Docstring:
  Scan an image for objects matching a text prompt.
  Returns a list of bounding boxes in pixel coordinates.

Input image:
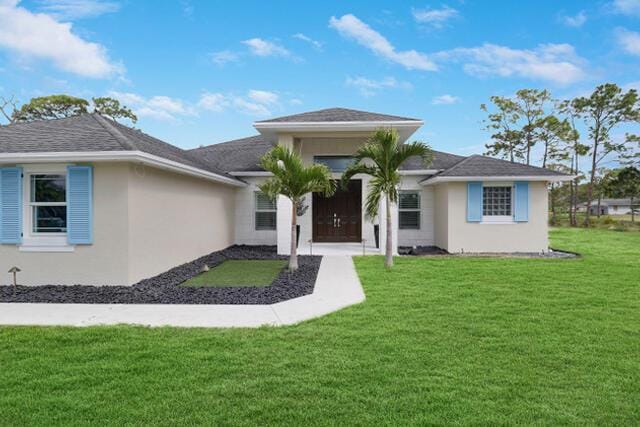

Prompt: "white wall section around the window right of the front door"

[398,176,435,246]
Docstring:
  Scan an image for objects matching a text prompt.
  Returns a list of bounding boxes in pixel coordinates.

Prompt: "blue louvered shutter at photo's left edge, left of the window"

[0,168,22,245]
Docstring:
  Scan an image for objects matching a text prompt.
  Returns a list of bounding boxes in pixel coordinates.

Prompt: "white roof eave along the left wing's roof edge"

[0,151,247,187]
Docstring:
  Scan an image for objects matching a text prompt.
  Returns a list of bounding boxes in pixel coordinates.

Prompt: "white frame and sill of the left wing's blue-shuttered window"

[19,164,74,252]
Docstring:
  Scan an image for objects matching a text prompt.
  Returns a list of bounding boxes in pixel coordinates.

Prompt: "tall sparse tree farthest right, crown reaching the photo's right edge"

[572,83,640,226]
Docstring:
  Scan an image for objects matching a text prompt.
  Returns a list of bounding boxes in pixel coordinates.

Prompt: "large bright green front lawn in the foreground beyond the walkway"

[0,229,640,425]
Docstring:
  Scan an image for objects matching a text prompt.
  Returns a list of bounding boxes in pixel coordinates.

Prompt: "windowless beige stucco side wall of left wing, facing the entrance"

[128,165,236,283]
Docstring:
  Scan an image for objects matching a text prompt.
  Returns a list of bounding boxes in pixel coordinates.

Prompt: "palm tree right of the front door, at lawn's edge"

[342,128,432,268]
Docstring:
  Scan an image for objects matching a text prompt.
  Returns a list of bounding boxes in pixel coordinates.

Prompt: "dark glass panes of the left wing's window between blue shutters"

[29,174,67,234]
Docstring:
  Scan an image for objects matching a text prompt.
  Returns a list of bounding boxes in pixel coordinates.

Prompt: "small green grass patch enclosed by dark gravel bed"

[180,259,287,287]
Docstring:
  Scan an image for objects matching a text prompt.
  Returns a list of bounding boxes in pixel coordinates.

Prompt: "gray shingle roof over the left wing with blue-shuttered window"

[0,114,234,179]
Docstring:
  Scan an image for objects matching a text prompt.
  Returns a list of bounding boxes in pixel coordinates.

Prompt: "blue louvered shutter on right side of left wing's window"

[67,166,93,245]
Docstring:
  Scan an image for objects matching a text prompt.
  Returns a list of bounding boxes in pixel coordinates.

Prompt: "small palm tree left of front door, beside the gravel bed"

[259,145,335,271]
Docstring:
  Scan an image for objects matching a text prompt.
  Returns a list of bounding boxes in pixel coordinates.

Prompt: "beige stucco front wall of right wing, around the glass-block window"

[436,182,549,253]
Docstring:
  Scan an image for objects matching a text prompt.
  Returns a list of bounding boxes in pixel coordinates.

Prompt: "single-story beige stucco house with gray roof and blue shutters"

[0,108,571,285]
